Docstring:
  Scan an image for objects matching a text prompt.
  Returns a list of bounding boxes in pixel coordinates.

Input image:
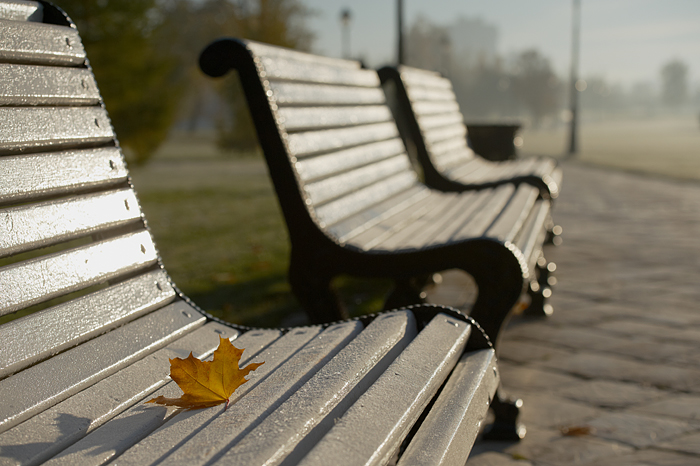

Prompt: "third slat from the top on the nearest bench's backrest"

[0,64,101,106]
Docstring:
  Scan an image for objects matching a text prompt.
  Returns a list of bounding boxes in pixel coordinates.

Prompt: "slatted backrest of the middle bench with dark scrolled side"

[200,39,422,245]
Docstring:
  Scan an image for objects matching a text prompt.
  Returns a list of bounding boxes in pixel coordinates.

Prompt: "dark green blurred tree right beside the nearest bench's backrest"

[61,0,184,163]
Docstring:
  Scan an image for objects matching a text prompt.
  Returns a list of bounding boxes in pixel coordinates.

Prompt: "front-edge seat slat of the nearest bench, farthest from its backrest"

[398,349,499,466]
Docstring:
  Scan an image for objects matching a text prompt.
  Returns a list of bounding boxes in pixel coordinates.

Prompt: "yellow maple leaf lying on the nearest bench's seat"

[146,337,264,409]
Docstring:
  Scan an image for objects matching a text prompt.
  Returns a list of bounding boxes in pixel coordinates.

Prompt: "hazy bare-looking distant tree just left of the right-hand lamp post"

[513,49,561,127]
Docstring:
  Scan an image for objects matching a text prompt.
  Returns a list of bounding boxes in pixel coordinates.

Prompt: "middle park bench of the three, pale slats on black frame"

[200,39,553,336]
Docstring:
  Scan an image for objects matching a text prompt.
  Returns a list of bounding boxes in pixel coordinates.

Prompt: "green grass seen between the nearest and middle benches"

[134,160,390,327]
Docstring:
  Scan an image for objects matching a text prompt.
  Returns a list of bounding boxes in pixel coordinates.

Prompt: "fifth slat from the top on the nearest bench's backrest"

[0,147,128,203]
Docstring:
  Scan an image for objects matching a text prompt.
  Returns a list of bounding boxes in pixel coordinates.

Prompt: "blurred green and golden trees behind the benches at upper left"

[61,0,312,163]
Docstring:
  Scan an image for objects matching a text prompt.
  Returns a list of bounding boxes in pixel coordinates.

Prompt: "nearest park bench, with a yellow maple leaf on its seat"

[0,1,516,465]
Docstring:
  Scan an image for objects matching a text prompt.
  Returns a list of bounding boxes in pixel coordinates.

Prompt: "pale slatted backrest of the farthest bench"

[379,66,476,179]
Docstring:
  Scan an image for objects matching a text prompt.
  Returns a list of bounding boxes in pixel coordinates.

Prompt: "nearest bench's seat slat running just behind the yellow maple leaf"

[0,322,239,464]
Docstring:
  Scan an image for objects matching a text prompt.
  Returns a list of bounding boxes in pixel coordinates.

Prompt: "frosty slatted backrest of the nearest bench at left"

[0,1,177,378]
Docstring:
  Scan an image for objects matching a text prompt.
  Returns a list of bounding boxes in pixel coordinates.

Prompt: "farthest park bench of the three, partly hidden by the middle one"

[378,66,562,199]
